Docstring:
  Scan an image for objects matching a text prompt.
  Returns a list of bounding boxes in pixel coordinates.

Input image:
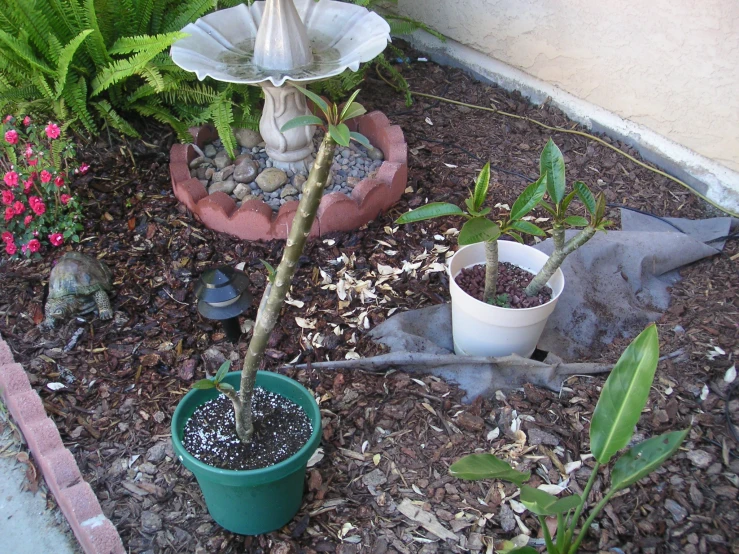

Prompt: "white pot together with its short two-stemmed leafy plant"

[397,139,610,357]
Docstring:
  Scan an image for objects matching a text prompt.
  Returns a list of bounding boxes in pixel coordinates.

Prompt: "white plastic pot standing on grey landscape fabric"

[449,241,565,358]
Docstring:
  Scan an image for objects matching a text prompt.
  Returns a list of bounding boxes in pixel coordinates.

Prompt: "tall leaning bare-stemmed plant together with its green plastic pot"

[172,87,369,535]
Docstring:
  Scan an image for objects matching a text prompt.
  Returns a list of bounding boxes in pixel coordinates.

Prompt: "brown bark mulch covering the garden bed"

[0,48,739,554]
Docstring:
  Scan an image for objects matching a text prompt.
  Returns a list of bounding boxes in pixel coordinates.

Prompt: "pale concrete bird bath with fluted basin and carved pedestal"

[171,0,390,173]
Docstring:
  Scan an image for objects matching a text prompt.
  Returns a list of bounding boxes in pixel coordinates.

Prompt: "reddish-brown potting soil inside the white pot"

[454,262,552,308]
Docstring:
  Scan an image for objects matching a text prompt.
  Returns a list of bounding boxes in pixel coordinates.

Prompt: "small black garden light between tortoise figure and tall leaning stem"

[195,266,252,343]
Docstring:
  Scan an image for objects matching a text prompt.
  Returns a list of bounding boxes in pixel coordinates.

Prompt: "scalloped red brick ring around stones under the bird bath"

[169,111,408,240]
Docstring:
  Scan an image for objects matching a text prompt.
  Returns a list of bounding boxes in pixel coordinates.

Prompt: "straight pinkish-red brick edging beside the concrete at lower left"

[0,338,126,554]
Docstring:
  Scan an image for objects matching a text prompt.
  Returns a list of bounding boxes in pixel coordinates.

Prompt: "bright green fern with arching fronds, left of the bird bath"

[0,0,258,153]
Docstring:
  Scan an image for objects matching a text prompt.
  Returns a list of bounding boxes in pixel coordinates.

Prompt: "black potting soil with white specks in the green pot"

[182,387,313,469]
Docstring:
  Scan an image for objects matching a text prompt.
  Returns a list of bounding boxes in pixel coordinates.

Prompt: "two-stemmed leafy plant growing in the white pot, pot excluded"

[396,139,610,304]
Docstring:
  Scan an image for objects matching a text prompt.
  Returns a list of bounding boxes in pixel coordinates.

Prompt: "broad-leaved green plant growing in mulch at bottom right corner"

[449,325,689,554]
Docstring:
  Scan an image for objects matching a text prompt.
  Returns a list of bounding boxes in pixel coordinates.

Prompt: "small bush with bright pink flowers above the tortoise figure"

[0,115,89,257]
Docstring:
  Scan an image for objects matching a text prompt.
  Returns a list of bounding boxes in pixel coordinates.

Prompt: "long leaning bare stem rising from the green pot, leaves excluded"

[236,133,336,443]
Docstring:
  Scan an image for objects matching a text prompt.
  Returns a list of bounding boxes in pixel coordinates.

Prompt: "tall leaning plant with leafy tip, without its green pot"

[195,91,369,443]
